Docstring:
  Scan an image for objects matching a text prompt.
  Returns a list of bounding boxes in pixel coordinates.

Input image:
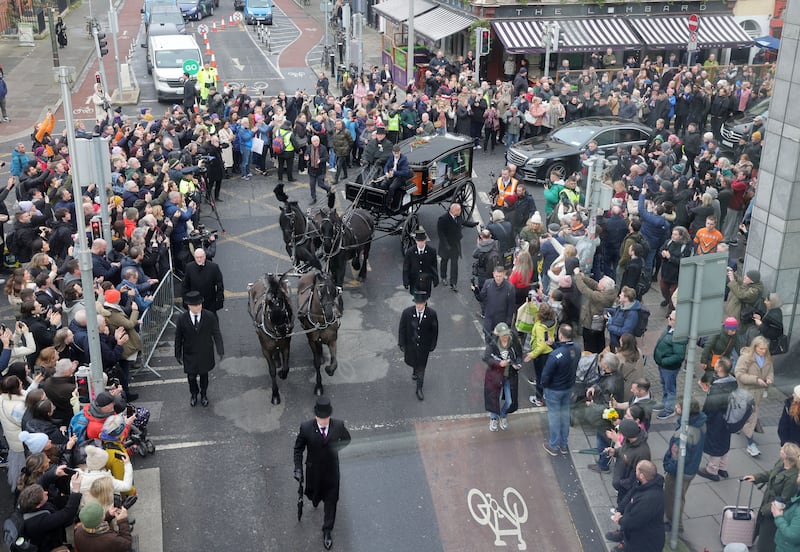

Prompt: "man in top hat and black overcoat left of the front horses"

[175,291,225,406]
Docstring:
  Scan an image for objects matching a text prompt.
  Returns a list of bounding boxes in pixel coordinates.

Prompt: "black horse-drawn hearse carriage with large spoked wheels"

[345,134,475,253]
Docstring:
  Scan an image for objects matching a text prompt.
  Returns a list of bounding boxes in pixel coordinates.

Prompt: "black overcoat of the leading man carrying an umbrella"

[294,418,350,506]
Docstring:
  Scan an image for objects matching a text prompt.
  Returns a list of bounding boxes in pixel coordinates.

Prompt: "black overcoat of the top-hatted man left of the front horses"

[175,309,225,374]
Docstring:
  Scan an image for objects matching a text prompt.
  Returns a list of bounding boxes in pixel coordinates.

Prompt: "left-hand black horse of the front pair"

[248,274,294,404]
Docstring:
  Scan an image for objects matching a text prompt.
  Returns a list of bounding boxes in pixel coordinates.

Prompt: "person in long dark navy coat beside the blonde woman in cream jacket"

[697,357,739,481]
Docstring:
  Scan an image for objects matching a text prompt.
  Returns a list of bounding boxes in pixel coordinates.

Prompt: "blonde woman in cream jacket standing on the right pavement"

[736,335,775,456]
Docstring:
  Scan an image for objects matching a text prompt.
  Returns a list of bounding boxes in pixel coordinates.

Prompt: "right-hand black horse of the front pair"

[297,270,344,395]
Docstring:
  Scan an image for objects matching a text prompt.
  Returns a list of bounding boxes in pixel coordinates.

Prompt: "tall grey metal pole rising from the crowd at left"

[56,67,105,396]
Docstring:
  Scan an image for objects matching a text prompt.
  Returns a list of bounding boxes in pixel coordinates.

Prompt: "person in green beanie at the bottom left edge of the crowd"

[75,502,132,552]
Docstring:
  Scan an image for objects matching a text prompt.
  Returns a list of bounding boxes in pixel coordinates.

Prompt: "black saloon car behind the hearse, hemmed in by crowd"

[508,117,652,184]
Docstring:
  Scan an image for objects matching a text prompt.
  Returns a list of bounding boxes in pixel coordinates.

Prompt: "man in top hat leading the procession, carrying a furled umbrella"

[294,395,350,550]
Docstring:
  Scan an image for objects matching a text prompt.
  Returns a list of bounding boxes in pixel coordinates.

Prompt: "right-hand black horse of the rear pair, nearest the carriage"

[313,205,375,286]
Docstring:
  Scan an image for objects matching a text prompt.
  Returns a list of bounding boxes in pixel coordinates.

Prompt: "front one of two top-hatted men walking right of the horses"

[397,291,439,400]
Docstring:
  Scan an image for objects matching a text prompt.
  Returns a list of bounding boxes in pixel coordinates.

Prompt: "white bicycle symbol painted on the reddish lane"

[467,487,528,550]
